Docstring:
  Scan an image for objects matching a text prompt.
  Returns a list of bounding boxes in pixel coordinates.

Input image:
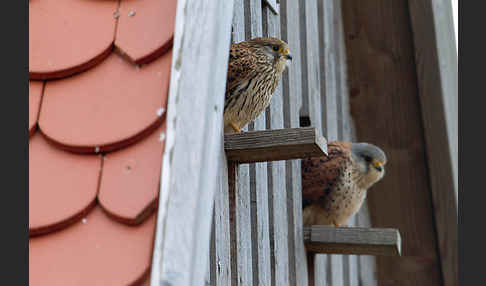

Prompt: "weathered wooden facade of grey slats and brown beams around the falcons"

[151,0,458,286]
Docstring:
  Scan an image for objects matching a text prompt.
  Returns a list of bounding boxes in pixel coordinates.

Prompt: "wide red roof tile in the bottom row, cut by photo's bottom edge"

[29,207,156,286]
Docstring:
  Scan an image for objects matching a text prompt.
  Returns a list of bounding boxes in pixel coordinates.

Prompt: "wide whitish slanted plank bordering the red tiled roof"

[150,0,233,286]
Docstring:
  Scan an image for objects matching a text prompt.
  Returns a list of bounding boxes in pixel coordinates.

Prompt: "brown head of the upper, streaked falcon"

[248,38,292,73]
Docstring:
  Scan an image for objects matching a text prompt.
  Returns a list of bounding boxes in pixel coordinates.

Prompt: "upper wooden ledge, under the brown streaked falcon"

[224,127,327,163]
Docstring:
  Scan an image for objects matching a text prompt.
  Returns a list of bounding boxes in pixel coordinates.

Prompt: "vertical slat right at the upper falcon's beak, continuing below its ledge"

[280,0,307,285]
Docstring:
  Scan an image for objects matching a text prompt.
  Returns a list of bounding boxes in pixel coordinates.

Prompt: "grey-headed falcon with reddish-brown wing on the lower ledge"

[302,141,386,226]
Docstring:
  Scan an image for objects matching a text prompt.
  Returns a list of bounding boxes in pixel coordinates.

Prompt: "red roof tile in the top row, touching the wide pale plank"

[115,0,177,64]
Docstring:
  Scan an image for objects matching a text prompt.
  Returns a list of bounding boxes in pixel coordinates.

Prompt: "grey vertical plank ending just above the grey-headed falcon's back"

[299,0,322,134]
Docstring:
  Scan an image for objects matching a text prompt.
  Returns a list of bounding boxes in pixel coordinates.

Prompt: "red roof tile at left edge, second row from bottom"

[29,134,101,235]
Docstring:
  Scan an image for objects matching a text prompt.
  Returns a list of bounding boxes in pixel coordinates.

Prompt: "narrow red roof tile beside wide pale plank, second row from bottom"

[98,124,165,224]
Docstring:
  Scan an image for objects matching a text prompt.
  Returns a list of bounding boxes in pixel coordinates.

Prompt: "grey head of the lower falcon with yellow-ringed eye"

[351,143,387,189]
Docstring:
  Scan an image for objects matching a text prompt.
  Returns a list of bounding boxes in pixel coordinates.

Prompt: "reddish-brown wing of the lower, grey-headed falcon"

[302,142,350,208]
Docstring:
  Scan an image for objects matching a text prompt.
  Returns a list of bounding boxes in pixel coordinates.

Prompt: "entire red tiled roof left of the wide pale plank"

[29,0,177,286]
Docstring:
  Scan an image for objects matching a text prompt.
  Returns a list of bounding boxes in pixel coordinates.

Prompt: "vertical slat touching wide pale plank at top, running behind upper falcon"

[232,0,256,286]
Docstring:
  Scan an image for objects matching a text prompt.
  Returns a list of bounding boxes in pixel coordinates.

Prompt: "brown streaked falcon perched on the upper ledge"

[224,38,292,134]
